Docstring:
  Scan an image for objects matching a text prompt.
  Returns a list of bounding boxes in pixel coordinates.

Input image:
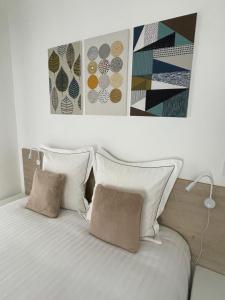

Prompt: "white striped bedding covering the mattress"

[0,199,190,300]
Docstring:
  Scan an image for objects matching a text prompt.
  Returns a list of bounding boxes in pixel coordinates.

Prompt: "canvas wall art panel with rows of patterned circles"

[84,30,130,115]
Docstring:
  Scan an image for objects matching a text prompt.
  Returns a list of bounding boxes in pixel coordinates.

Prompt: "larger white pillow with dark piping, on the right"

[87,149,183,241]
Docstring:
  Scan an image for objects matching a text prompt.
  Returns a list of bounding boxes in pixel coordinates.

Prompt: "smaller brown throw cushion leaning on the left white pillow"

[26,169,65,218]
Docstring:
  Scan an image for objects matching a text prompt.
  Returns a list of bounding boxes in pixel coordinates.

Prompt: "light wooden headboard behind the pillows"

[22,149,225,275]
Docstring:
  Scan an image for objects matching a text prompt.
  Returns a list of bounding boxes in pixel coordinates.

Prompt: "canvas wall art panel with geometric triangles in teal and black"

[130,13,197,117]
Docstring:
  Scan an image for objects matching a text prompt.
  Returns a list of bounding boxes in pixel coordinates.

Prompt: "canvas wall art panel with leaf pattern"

[48,41,83,115]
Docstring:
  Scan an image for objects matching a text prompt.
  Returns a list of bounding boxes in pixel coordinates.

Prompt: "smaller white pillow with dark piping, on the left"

[40,146,94,212]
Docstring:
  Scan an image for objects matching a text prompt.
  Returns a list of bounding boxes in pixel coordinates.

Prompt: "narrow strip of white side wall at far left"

[0,1,20,199]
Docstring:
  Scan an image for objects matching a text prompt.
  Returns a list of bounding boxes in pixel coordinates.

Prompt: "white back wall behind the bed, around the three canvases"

[9,0,225,185]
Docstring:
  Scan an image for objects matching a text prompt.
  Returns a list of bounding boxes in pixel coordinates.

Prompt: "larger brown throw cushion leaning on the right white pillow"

[89,184,143,252]
